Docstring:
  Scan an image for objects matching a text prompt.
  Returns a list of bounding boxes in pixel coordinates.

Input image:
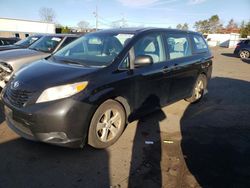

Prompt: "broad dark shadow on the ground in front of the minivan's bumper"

[0,138,110,188]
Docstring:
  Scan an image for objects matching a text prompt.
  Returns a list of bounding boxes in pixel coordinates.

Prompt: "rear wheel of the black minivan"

[185,74,207,103]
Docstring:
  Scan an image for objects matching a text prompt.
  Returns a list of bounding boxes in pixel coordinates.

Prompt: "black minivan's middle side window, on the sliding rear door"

[167,34,192,59]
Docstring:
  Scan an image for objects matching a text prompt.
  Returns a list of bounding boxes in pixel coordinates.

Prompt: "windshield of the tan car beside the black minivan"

[29,36,63,53]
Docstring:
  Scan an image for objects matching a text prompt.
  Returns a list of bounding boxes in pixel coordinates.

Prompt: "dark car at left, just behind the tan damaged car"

[0,35,43,51]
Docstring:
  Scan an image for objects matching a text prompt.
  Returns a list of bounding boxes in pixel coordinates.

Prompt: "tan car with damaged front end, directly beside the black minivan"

[0,34,79,88]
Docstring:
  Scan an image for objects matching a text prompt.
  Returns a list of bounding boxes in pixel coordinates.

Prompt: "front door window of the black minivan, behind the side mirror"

[134,34,166,63]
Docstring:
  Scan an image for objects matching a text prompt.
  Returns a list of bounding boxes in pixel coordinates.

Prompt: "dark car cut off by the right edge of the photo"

[234,39,250,59]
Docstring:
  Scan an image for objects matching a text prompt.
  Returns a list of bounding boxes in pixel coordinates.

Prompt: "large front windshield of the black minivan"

[53,33,133,67]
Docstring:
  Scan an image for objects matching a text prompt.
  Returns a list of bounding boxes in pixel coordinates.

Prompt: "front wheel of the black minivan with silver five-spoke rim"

[88,100,126,149]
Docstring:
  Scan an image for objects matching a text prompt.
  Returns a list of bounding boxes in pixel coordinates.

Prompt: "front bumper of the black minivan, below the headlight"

[3,98,94,147]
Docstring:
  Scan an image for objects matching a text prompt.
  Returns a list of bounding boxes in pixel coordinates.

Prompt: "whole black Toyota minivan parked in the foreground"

[2,28,212,148]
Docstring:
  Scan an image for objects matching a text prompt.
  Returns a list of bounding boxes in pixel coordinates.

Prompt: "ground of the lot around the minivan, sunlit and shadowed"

[0,48,250,188]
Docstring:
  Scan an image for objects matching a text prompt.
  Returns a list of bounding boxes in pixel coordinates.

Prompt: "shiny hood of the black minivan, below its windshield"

[14,59,99,91]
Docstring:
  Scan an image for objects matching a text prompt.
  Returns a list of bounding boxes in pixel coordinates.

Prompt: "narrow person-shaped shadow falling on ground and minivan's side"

[128,95,166,187]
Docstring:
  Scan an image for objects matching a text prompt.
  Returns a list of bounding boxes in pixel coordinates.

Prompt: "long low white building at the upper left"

[0,18,55,38]
